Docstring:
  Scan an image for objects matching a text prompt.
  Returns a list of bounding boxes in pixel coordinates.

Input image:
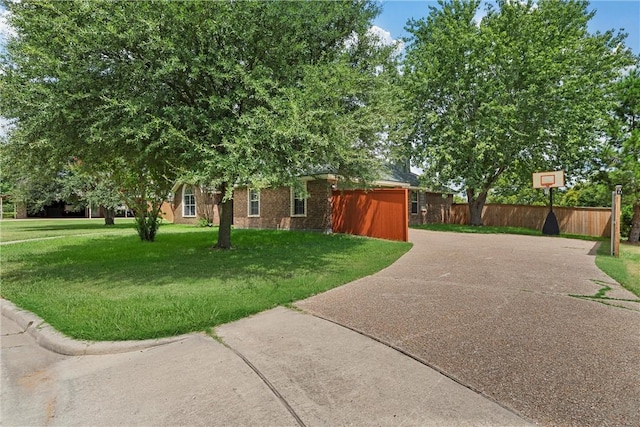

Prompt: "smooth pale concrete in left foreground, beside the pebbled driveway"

[1,301,528,426]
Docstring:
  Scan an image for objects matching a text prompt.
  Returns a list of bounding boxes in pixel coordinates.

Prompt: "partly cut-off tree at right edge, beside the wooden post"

[609,66,640,244]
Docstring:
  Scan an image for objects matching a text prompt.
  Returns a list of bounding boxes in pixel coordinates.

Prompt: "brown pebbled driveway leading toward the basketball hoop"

[296,230,640,426]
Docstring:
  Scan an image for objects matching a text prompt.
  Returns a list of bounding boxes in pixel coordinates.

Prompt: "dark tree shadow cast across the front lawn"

[5,230,365,287]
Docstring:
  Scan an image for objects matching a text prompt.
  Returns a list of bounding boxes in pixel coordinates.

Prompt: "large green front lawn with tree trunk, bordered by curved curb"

[0,220,411,340]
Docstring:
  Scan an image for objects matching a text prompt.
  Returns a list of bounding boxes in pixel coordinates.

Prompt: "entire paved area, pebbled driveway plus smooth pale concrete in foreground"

[0,230,640,426]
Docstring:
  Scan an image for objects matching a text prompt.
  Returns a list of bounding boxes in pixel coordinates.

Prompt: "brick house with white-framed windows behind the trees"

[162,166,453,231]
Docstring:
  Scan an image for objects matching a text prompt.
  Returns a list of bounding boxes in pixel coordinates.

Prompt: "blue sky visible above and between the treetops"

[374,0,640,55]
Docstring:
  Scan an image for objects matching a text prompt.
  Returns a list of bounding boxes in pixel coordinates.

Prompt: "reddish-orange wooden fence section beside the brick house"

[331,188,409,242]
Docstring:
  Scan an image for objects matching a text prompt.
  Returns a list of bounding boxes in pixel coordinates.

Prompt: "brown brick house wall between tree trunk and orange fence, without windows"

[233,180,332,231]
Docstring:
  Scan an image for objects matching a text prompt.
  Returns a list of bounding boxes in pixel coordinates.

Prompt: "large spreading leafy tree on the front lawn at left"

[0,0,395,248]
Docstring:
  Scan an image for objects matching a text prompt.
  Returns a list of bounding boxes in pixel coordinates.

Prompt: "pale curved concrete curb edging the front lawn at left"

[0,298,188,356]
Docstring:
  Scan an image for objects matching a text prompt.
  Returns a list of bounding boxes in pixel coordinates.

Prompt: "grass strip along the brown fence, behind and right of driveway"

[413,224,640,296]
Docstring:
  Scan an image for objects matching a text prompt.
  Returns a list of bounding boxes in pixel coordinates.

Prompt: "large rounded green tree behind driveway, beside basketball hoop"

[403,0,632,225]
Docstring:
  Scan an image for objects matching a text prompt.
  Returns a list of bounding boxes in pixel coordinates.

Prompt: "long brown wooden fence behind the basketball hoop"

[449,203,611,237]
